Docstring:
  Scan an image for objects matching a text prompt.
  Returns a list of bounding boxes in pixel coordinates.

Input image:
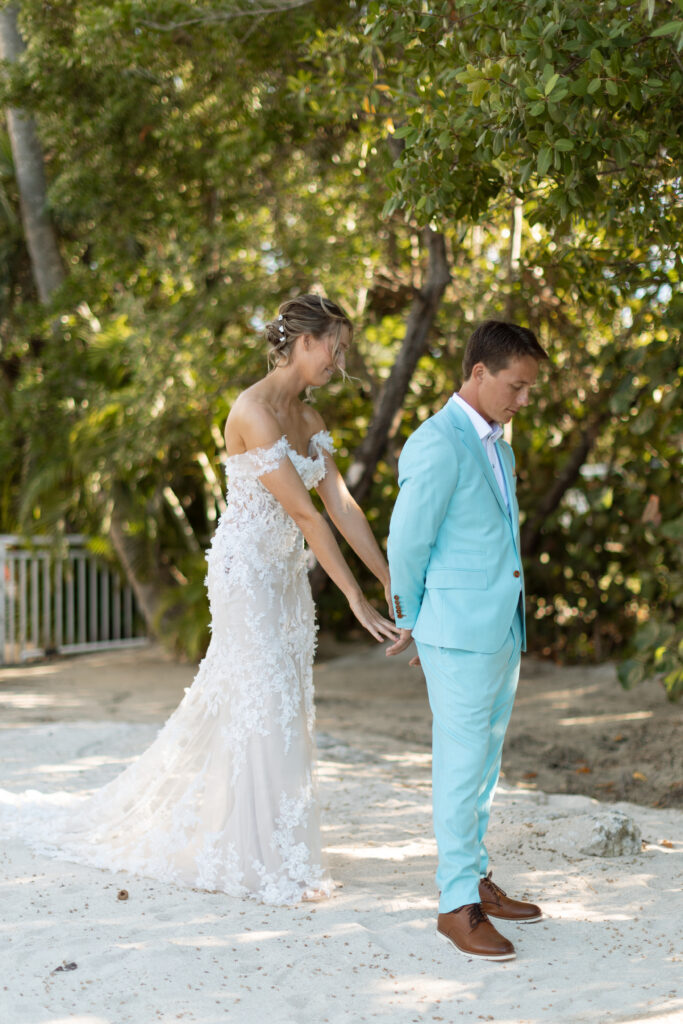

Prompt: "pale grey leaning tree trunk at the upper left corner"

[0,4,66,304]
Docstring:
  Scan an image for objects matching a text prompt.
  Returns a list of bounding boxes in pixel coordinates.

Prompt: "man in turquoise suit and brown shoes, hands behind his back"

[387,319,548,961]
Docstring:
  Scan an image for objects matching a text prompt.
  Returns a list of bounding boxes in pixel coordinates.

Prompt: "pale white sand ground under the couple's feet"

[0,647,683,1024]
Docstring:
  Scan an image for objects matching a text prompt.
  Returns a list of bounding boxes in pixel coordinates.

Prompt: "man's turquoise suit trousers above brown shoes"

[417,611,522,913]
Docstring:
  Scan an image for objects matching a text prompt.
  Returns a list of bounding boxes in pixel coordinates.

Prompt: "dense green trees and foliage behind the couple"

[0,0,683,696]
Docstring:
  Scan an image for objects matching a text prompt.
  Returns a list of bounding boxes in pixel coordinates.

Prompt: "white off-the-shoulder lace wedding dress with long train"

[0,431,334,904]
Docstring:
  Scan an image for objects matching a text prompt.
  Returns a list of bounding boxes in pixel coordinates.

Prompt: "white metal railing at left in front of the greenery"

[0,534,147,665]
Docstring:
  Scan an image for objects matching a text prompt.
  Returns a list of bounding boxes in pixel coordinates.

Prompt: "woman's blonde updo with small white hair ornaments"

[265,295,353,370]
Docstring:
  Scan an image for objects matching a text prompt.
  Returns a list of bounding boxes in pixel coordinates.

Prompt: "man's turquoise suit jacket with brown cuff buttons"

[387,400,526,653]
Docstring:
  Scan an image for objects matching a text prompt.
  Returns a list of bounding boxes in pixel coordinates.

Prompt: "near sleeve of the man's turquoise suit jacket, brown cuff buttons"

[387,421,458,630]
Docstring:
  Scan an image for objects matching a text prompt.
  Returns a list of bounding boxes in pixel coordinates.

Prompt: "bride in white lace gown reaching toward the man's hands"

[1,295,397,904]
